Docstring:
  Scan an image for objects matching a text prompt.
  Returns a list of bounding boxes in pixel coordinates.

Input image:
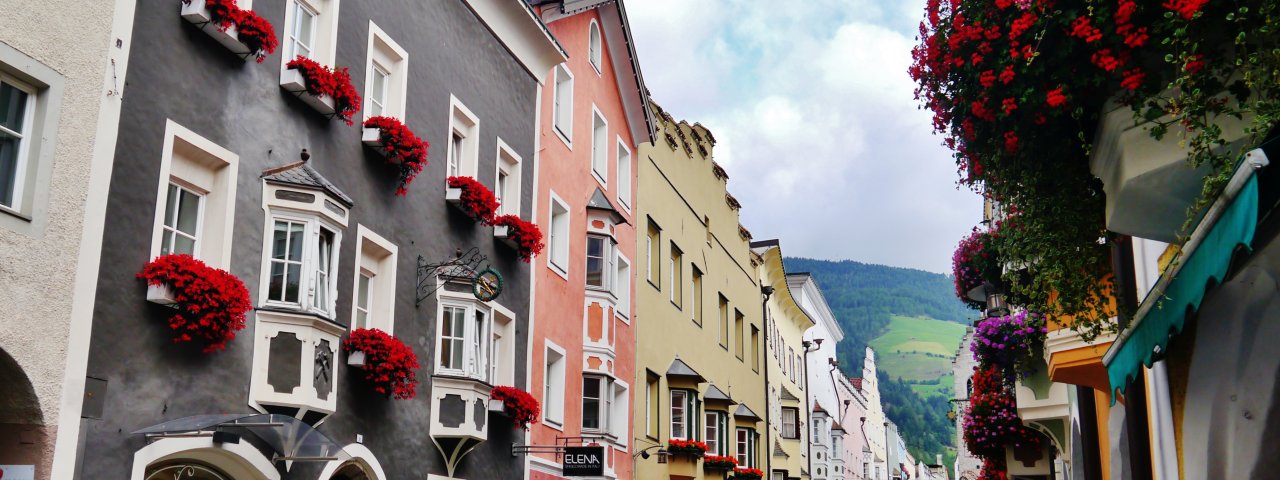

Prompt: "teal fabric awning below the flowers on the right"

[1103,175,1258,401]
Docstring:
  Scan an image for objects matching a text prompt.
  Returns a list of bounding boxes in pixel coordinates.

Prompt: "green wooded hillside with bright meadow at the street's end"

[783,259,978,471]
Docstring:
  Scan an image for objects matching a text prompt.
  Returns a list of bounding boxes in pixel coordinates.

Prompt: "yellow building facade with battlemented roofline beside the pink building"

[632,104,762,479]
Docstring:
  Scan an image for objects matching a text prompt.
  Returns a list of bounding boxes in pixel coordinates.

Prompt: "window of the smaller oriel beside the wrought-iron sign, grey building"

[435,300,493,381]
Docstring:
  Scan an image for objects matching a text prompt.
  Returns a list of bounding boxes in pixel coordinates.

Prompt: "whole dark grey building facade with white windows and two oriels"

[77,0,563,479]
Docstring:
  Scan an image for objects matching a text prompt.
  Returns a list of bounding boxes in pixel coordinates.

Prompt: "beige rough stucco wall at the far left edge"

[0,0,115,479]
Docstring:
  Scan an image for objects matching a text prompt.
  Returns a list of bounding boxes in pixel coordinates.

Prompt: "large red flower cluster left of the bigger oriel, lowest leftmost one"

[137,255,253,353]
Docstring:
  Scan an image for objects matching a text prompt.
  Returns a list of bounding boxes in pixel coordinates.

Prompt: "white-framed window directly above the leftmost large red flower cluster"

[150,120,240,267]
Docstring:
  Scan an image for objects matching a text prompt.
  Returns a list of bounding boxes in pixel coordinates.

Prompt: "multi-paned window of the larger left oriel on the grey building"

[266,215,339,317]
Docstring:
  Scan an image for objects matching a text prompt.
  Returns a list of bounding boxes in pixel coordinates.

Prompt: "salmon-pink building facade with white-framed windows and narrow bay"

[529,0,653,479]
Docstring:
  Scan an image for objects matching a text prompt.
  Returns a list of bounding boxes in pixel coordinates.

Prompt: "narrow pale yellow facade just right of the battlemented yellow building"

[751,241,815,480]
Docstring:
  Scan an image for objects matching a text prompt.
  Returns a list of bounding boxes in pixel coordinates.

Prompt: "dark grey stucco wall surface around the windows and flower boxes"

[83,0,538,479]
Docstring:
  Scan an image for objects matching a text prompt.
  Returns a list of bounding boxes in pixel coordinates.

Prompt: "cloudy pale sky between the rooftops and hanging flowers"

[626,0,982,273]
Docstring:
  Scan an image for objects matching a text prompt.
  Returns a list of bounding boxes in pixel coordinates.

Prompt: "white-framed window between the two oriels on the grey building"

[351,225,397,333]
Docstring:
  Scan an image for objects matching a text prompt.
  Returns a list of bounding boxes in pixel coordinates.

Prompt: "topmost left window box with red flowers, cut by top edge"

[179,0,279,63]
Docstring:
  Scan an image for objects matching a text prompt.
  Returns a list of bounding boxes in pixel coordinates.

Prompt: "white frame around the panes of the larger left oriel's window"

[261,209,343,320]
